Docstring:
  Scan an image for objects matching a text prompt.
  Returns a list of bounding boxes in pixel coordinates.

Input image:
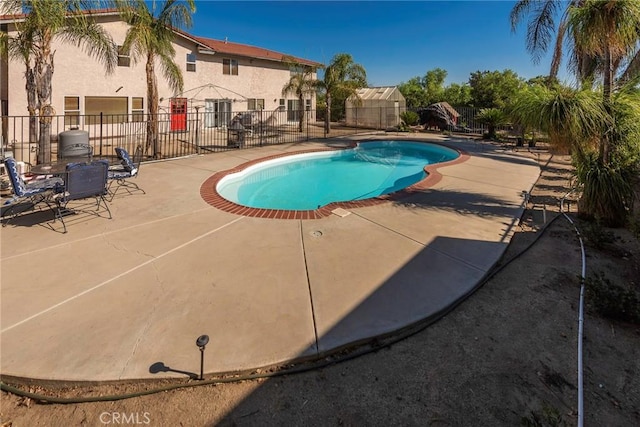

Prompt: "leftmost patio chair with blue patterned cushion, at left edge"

[2,157,64,226]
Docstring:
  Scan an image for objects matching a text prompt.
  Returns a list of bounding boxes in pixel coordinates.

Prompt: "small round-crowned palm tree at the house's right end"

[318,53,367,134]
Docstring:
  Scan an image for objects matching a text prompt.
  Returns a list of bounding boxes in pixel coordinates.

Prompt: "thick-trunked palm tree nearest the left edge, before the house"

[0,0,118,163]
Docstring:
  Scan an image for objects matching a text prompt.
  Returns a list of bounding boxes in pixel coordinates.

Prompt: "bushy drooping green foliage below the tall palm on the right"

[510,82,640,226]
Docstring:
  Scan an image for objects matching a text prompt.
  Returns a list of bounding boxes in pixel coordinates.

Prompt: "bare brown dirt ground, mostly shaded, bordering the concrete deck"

[0,148,640,427]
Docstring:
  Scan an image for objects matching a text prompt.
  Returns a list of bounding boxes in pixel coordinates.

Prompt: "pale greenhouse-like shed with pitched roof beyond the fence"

[345,86,407,129]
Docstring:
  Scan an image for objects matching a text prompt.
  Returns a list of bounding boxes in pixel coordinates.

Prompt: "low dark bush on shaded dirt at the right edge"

[585,272,640,324]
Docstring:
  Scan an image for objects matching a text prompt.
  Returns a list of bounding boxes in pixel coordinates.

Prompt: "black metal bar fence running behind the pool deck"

[0,106,480,164]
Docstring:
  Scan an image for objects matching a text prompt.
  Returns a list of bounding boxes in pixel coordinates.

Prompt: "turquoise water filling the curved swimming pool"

[216,141,459,210]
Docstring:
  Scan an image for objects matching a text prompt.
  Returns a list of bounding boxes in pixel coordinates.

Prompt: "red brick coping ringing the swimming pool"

[200,140,469,219]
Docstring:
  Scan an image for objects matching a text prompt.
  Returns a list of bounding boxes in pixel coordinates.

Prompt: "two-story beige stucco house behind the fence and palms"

[0,10,321,131]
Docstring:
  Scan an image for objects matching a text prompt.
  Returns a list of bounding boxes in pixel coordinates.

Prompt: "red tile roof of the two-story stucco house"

[0,9,322,67]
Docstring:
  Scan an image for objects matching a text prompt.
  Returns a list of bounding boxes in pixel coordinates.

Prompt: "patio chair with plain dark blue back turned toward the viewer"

[54,160,112,233]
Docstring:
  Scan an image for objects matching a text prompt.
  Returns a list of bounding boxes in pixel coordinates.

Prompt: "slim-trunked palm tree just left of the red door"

[115,0,195,158]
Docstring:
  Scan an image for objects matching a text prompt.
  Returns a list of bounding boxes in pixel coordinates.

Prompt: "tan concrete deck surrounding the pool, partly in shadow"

[0,134,540,381]
